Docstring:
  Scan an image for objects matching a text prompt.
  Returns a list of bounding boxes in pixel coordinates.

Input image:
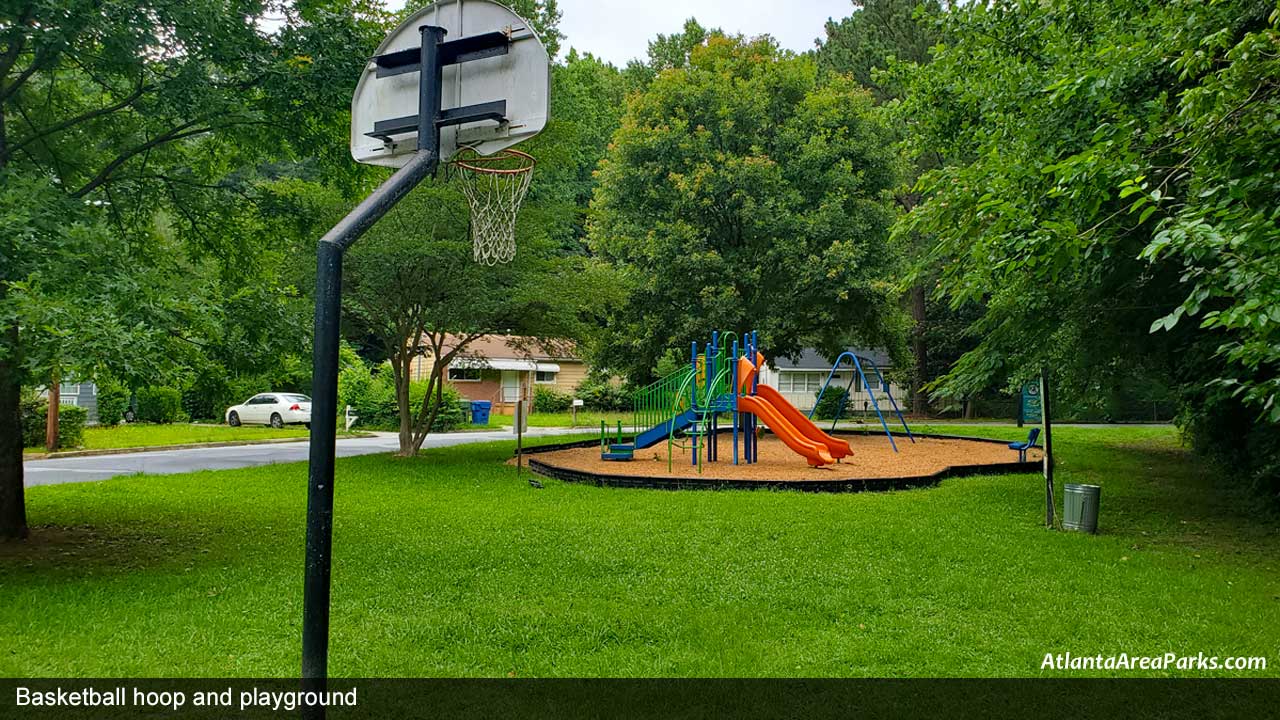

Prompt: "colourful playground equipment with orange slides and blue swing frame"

[600,332,915,471]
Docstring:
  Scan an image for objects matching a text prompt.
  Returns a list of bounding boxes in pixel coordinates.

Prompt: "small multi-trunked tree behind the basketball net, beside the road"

[344,182,607,456]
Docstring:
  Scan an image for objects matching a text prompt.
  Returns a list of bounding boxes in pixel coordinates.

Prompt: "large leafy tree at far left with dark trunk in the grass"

[0,0,381,537]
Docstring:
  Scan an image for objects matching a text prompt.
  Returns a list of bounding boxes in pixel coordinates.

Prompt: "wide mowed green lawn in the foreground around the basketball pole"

[0,427,1280,676]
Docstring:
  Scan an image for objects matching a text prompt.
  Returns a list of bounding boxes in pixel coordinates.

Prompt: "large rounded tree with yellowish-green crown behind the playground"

[590,36,897,380]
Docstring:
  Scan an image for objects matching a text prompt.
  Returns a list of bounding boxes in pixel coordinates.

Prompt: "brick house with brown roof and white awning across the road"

[410,336,588,415]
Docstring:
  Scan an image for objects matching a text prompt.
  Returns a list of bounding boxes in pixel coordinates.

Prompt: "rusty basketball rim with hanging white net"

[449,147,536,265]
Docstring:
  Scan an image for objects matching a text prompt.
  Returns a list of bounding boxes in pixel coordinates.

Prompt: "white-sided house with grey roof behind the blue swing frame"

[760,350,905,415]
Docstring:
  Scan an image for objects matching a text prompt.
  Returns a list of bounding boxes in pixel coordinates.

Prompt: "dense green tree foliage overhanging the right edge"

[899,0,1280,492]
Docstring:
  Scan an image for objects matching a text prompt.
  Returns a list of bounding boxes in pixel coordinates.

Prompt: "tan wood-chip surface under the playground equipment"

[531,433,1042,487]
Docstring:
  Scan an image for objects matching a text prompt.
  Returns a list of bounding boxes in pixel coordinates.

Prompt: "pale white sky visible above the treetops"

[378,0,852,68]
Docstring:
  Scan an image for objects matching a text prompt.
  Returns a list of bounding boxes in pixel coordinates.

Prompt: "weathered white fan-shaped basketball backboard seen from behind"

[351,0,550,168]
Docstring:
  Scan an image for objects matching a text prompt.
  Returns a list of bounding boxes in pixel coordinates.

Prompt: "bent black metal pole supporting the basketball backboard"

[302,23,444,696]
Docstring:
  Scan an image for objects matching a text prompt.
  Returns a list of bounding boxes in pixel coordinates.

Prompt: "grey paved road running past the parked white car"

[23,428,591,487]
